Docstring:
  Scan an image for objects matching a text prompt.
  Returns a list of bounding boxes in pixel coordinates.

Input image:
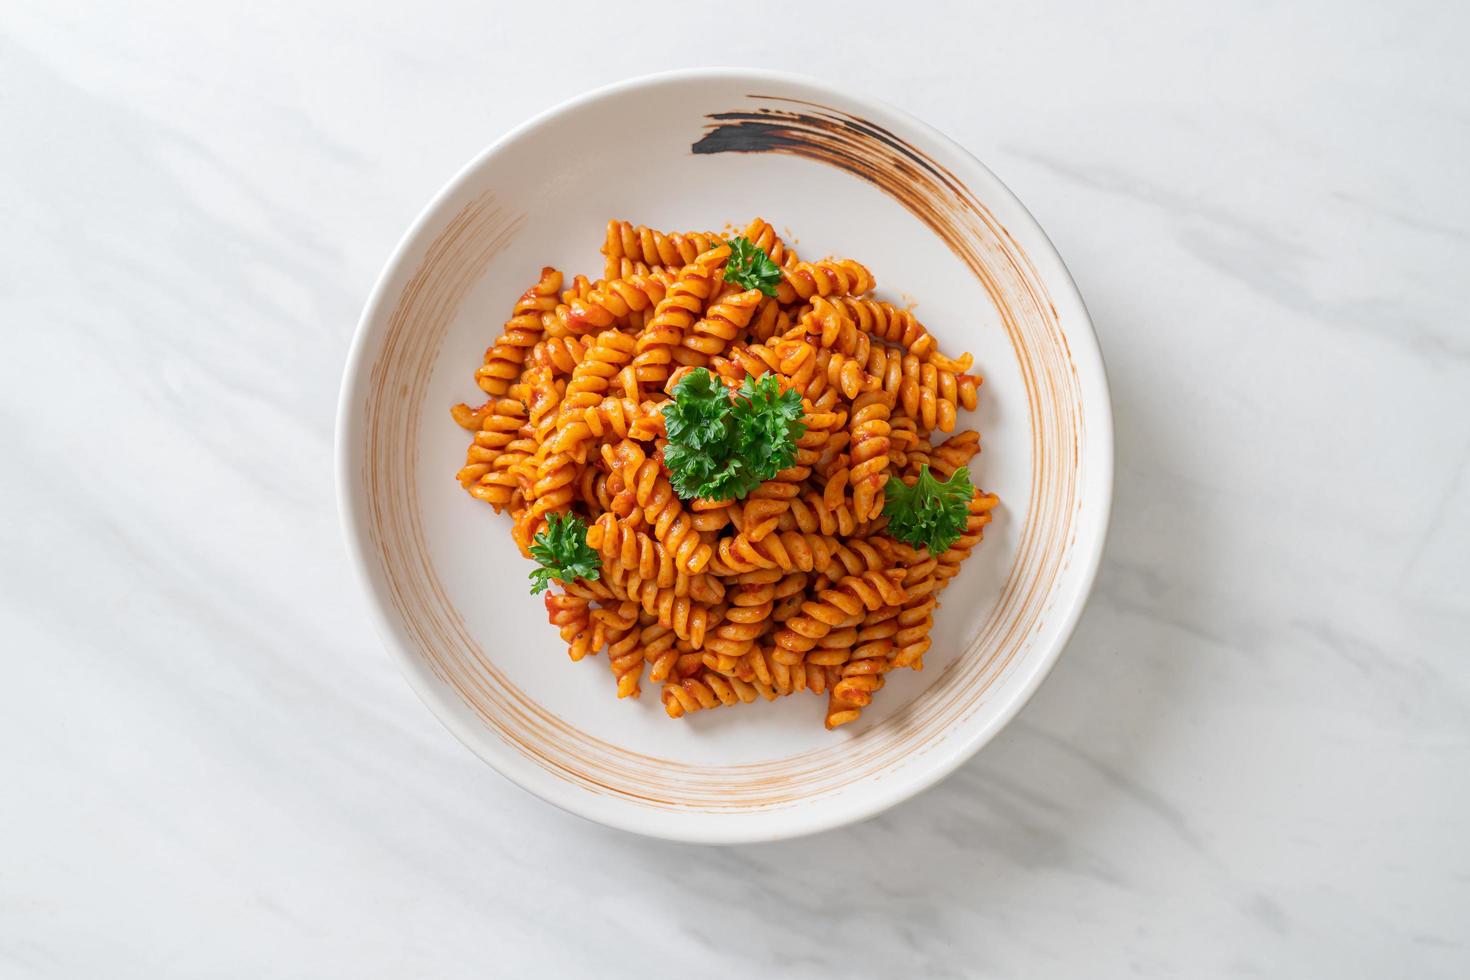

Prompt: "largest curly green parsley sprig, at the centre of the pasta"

[663,369,807,500]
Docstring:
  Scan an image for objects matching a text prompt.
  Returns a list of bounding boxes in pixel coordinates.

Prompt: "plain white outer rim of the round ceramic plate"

[334,68,1116,843]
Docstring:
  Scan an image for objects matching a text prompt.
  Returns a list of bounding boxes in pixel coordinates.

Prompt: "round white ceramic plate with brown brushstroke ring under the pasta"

[337,69,1113,842]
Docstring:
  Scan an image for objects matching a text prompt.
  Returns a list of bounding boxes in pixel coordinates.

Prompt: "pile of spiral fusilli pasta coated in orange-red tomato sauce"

[453,219,998,729]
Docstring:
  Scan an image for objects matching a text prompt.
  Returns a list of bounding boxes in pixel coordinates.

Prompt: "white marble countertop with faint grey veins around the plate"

[0,0,1470,980]
